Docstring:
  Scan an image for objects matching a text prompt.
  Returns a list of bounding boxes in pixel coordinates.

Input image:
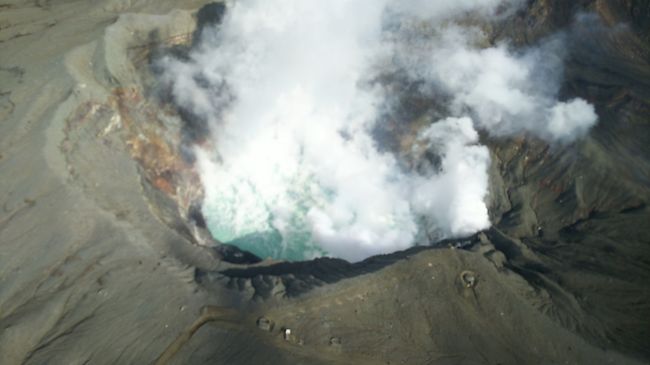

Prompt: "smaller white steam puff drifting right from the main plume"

[394,25,597,141]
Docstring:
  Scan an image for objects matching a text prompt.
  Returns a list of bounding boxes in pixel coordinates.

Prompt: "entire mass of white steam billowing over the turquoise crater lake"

[162,0,596,261]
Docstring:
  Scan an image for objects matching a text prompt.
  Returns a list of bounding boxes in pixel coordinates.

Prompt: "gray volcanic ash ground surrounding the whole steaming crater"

[0,0,650,364]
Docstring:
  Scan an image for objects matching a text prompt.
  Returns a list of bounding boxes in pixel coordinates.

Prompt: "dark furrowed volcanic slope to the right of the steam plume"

[486,2,650,353]
